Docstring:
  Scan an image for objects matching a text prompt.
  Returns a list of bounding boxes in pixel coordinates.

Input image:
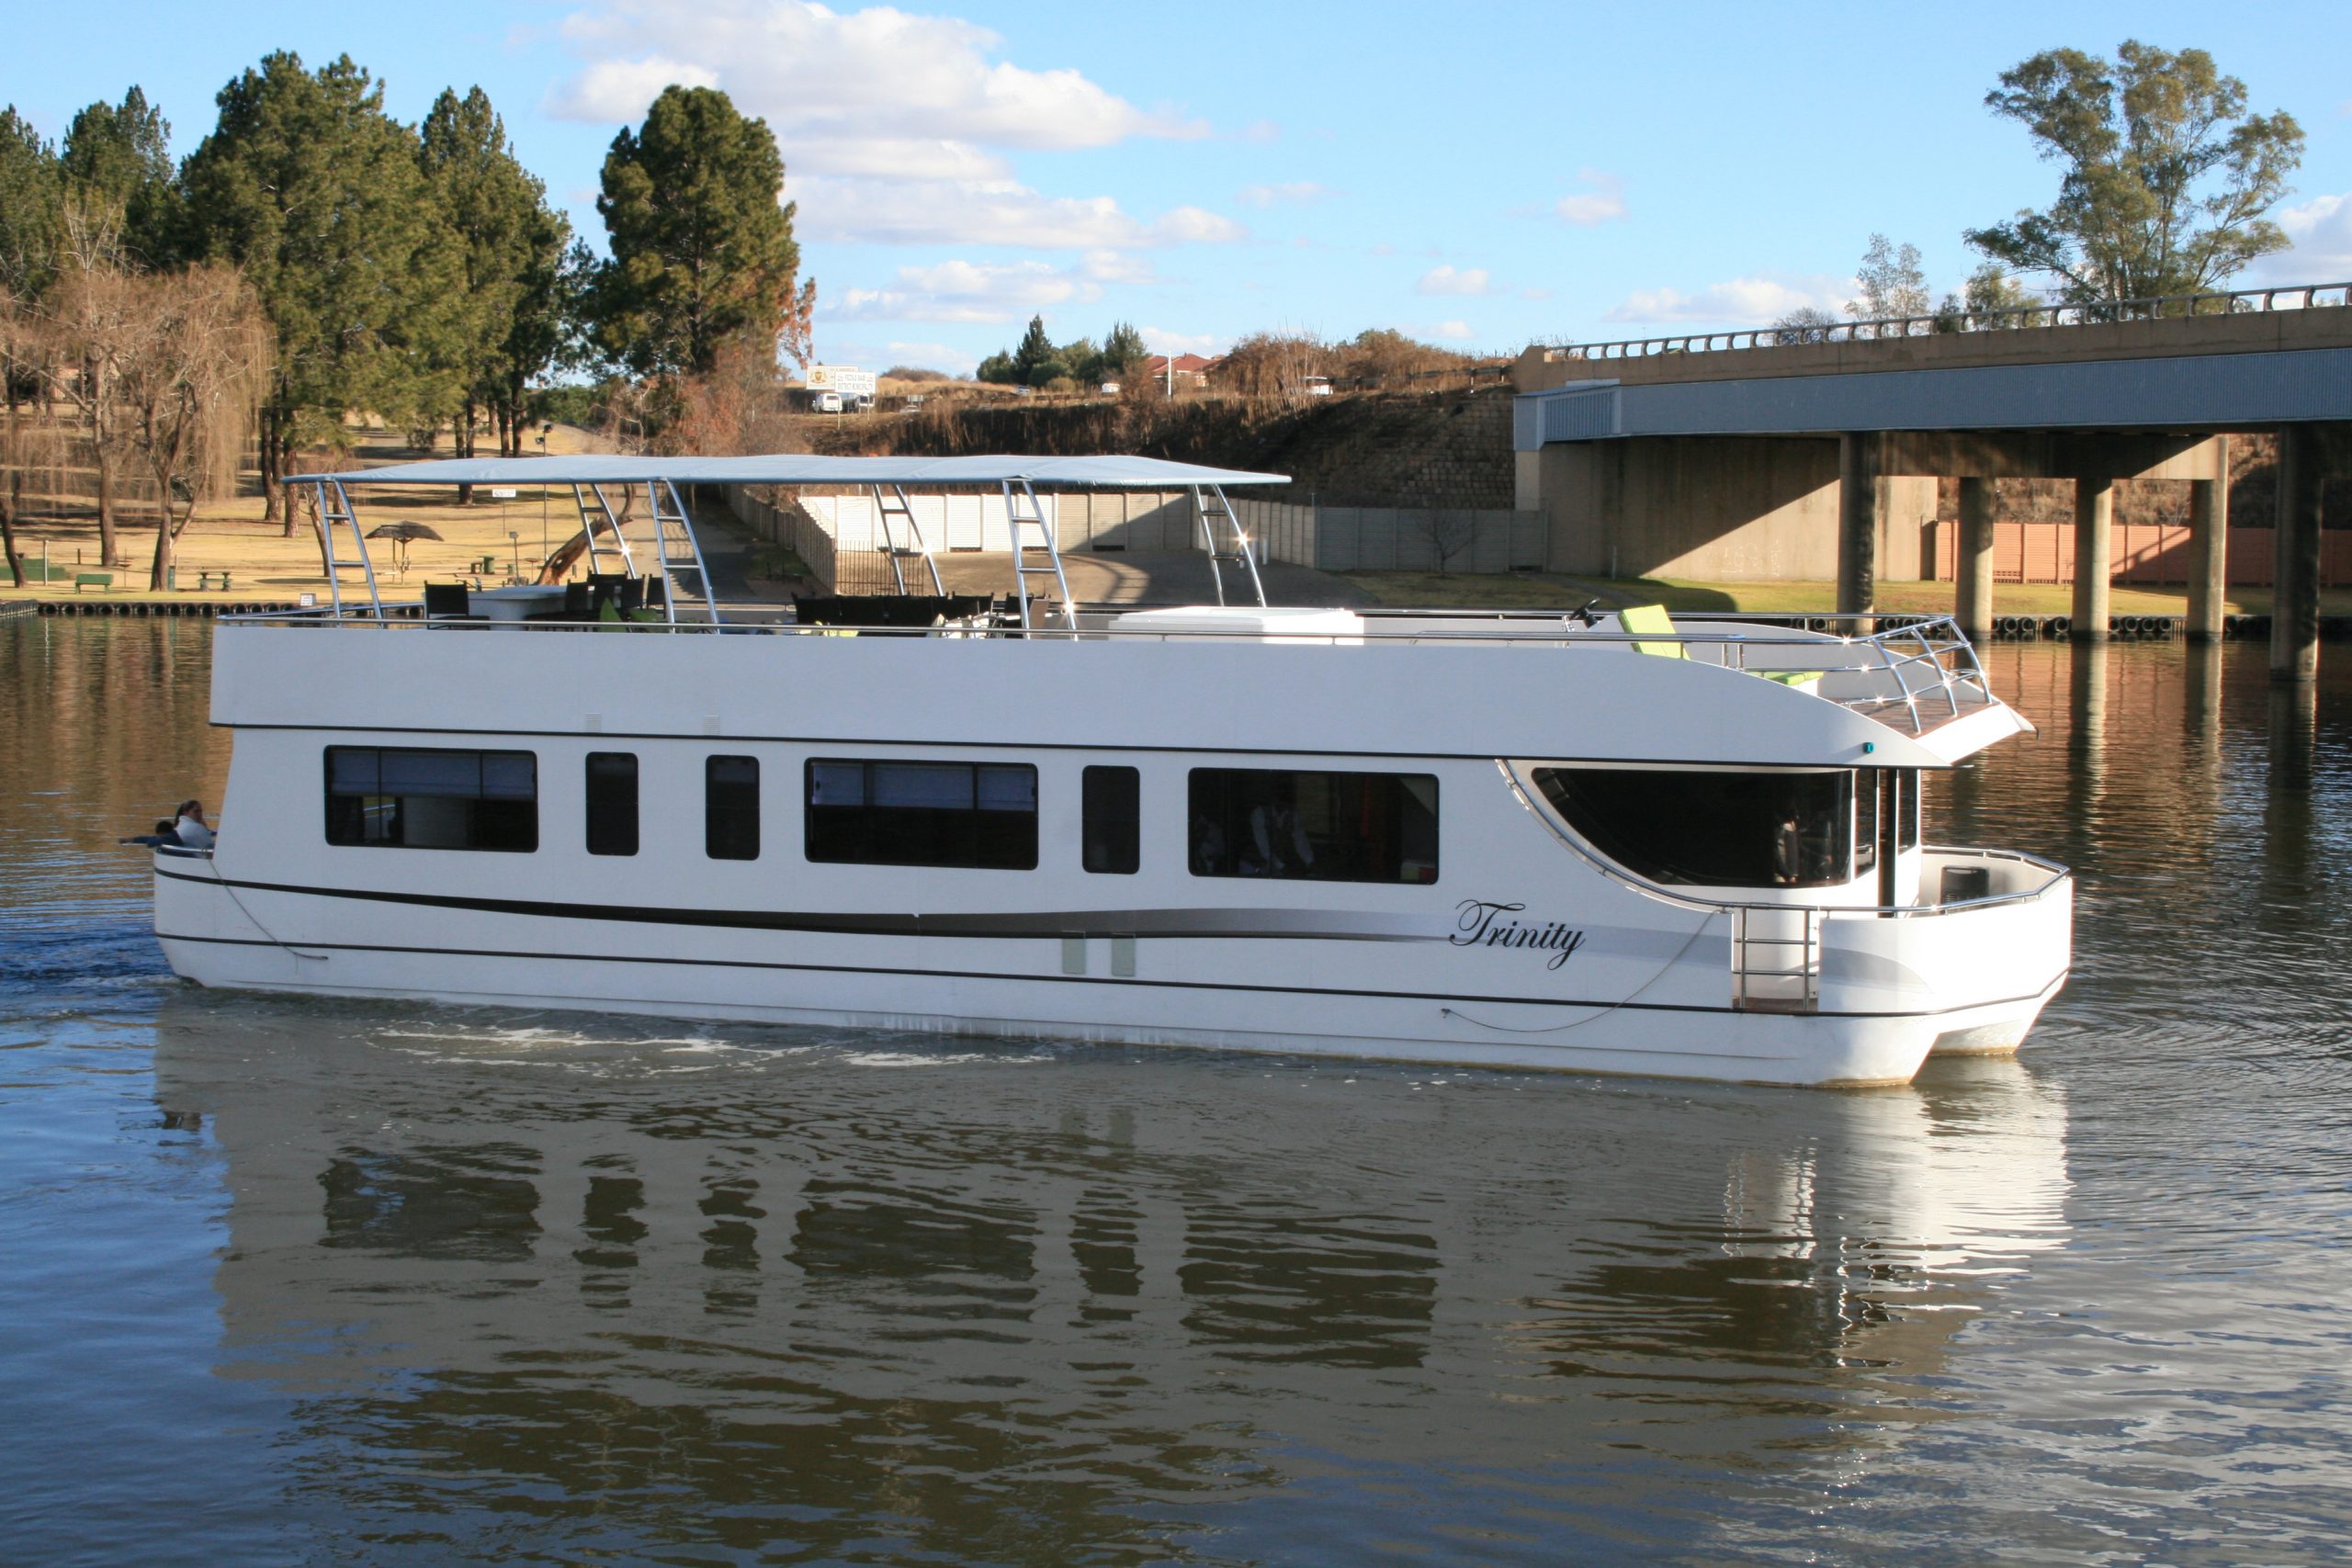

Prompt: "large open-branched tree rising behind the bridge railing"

[1966,40,2302,303]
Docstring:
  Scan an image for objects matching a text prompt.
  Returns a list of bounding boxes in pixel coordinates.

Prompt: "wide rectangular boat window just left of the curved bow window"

[1188,769,1437,882]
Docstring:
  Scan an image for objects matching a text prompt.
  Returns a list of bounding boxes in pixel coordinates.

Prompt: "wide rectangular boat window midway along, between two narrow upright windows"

[805,760,1037,872]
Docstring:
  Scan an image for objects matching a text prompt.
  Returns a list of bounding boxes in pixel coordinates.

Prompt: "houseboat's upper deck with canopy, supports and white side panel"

[257,454,2032,766]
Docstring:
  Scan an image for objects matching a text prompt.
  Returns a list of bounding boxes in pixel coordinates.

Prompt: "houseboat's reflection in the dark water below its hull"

[155,995,2067,1561]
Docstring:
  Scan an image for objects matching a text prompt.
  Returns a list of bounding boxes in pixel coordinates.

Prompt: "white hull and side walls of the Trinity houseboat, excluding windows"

[155,626,2070,1086]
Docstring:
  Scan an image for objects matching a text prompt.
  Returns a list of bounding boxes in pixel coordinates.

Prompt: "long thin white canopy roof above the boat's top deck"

[287,451,1289,489]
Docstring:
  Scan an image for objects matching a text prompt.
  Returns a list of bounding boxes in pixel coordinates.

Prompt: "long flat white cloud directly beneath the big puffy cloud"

[793,176,1249,252]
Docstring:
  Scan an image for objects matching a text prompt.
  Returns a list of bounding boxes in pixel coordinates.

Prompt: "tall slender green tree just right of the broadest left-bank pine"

[416,87,571,472]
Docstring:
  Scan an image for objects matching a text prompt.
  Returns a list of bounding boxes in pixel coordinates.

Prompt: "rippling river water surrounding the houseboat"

[0,621,2352,1563]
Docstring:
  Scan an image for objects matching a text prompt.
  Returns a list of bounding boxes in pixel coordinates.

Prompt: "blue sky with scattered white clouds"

[0,0,2352,374]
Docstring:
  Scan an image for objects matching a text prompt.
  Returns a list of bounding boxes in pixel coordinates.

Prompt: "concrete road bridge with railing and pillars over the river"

[1512,282,2352,680]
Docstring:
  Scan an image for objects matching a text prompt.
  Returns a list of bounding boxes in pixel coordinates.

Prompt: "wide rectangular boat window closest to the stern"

[327,745,538,851]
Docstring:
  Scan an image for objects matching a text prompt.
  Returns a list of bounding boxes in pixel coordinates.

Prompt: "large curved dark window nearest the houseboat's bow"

[1536,769,1853,886]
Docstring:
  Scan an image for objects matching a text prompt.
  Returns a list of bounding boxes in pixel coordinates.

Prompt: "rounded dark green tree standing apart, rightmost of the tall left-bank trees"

[595,85,816,378]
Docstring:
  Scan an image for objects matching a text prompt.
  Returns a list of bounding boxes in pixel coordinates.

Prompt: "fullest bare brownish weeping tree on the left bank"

[118,265,270,590]
